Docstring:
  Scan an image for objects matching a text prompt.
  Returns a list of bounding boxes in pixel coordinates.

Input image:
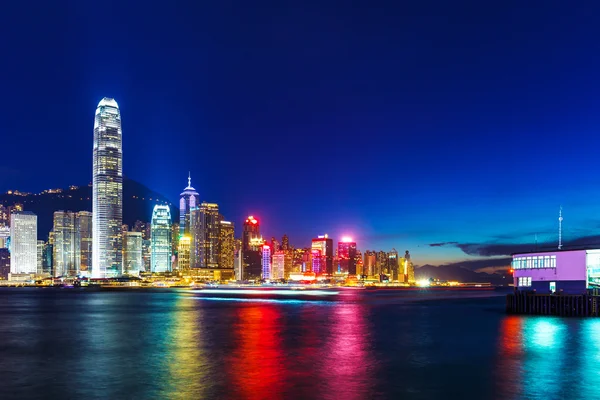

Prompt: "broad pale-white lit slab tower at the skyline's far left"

[10,211,37,274]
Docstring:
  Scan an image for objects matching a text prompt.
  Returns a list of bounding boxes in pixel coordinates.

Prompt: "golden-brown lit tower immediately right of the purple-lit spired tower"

[191,202,220,268]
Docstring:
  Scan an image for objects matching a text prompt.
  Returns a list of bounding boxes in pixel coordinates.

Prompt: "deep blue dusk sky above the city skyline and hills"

[0,0,600,264]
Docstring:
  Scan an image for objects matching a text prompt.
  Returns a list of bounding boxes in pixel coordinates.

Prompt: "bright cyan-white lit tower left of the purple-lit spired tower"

[151,205,171,272]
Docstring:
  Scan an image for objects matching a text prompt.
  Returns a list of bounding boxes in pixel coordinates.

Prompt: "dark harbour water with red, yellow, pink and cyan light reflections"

[0,289,600,399]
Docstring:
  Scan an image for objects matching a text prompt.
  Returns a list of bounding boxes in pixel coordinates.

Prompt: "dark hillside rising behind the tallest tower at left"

[0,178,179,240]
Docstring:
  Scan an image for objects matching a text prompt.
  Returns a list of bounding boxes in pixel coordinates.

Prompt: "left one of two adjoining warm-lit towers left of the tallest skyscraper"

[52,211,77,277]
